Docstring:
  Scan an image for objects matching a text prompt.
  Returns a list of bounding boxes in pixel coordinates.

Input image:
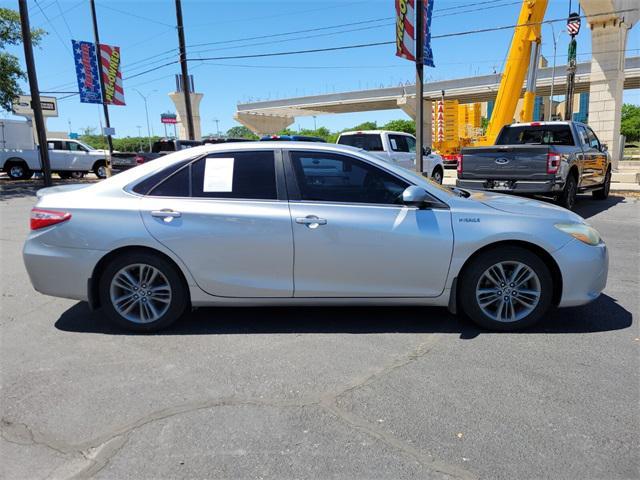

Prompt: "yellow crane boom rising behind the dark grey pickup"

[475,0,548,146]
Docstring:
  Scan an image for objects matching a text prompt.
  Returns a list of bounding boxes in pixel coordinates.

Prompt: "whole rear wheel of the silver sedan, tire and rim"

[99,252,188,332]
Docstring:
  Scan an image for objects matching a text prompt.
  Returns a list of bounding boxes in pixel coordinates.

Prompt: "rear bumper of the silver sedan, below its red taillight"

[22,234,105,301]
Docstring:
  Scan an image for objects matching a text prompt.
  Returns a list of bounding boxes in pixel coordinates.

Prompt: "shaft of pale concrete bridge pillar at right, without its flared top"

[589,21,628,169]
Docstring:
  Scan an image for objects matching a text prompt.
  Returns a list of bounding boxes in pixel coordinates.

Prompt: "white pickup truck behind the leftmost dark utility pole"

[0,138,108,180]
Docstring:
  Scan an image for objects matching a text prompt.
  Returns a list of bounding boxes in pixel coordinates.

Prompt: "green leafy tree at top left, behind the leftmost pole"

[0,8,46,111]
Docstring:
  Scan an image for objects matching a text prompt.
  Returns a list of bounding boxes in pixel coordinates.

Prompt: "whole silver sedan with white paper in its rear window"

[24,142,608,332]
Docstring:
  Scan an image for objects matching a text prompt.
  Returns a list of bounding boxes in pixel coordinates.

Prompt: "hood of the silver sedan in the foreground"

[471,192,584,223]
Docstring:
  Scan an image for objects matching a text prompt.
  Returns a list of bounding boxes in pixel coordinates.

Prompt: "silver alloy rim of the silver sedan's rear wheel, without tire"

[109,263,172,324]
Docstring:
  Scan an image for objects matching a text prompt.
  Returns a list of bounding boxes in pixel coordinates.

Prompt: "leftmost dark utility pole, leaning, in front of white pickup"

[18,0,52,187]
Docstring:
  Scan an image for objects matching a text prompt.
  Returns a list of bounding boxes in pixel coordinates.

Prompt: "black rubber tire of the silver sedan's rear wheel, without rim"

[98,252,189,333]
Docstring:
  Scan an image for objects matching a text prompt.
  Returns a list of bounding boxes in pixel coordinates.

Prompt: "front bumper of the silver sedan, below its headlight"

[553,240,609,307]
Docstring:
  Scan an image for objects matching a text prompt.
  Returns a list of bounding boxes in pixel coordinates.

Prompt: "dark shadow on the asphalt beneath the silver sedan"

[55,295,633,339]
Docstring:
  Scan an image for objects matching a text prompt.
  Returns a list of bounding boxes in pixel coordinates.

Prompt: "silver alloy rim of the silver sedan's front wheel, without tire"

[476,261,542,323]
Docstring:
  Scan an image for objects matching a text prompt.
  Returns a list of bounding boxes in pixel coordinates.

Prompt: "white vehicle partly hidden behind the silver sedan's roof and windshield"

[337,130,444,183]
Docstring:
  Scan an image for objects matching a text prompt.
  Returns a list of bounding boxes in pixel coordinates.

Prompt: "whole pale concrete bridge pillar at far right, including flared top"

[580,0,638,169]
